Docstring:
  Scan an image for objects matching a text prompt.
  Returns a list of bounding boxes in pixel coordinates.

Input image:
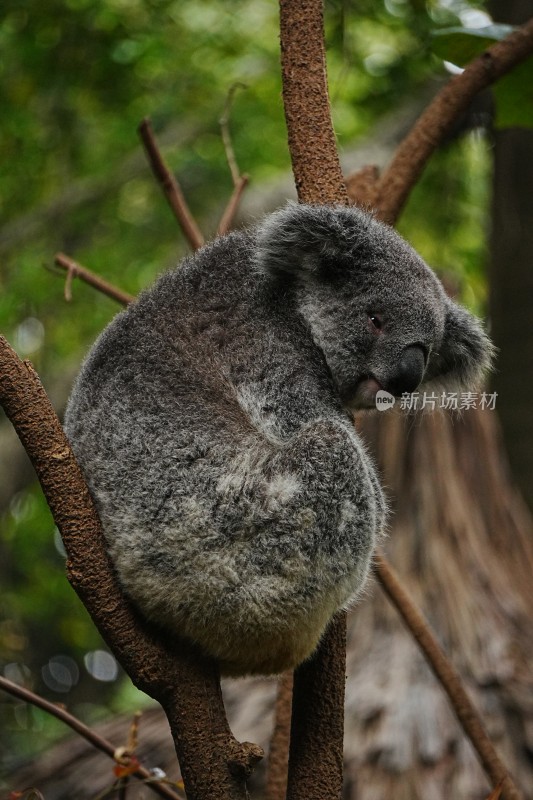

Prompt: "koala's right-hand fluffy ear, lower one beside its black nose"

[426,299,495,390]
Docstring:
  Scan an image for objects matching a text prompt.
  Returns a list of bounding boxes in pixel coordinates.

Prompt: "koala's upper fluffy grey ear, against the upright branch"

[254,203,368,277]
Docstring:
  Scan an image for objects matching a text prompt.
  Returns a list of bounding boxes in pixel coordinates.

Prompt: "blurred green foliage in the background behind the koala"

[0,0,489,789]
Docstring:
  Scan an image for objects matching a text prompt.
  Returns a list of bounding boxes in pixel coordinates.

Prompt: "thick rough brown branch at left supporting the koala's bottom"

[0,337,262,800]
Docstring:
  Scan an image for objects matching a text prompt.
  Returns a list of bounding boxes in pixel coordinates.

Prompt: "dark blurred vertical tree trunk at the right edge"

[489,0,533,509]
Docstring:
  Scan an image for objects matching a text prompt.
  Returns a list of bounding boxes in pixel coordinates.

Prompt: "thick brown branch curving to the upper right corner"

[376,19,533,225]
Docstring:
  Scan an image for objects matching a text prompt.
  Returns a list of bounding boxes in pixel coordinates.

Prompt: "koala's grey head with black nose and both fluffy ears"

[255,204,493,410]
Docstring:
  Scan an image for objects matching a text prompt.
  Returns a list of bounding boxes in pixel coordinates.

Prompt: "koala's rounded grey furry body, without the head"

[65,225,383,674]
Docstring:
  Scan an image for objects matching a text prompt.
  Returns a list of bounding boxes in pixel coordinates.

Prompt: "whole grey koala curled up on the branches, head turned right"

[65,204,492,676]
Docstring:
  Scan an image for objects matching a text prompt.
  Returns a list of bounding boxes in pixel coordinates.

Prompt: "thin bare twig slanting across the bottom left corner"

[0,676,182,800]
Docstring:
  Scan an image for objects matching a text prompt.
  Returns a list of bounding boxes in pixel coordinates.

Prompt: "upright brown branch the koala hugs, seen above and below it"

[280,0,348,800]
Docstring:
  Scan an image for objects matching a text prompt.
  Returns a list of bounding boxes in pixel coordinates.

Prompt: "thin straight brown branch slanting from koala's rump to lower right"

[374,553,523,800]
